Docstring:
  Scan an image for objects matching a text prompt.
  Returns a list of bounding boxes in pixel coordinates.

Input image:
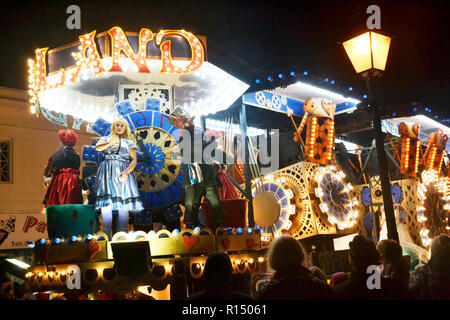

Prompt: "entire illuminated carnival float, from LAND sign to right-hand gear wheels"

[22,27,450,299]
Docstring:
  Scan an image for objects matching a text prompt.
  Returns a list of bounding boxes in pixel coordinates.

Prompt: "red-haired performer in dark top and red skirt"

[43,130,83,207]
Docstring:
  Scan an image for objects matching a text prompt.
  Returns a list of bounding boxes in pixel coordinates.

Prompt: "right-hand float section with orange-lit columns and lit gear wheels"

[212,71,450,252]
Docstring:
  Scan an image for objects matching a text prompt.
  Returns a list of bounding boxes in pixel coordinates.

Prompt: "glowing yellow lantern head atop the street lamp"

[343,31,391,76]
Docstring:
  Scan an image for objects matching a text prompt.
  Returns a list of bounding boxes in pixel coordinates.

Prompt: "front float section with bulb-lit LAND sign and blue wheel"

[26,27,265,299]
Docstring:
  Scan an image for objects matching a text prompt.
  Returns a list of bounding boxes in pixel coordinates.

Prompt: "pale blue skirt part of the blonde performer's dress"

[95,158,144,213]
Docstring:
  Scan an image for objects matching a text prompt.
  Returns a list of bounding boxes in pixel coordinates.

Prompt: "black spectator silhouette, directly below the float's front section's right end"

[187,252,251,300]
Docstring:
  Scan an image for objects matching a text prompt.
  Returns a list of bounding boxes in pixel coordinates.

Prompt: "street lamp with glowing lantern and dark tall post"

[343,31,399,242]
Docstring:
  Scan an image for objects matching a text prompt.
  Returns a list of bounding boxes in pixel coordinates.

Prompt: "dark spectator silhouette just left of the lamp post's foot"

[334,235,409,300]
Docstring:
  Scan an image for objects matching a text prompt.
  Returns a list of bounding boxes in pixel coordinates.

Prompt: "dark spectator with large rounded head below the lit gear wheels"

[256,235,336,300]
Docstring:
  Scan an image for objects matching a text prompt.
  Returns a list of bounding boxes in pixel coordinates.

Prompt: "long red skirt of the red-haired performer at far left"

[43,168,83,207]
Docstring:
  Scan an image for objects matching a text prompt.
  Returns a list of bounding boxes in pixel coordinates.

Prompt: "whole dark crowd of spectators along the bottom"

[0,234,450,301]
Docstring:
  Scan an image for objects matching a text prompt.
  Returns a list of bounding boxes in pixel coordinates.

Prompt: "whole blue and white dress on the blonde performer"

[95,137,144,213]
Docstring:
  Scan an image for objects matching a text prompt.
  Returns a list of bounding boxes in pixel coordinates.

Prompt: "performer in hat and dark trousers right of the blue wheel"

[169,107,225,228]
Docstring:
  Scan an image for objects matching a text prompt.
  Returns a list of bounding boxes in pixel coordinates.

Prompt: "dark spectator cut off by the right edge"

[409,234,450,300]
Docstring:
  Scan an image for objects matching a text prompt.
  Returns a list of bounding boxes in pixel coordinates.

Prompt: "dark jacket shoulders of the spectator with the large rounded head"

[256,266,336,300]
